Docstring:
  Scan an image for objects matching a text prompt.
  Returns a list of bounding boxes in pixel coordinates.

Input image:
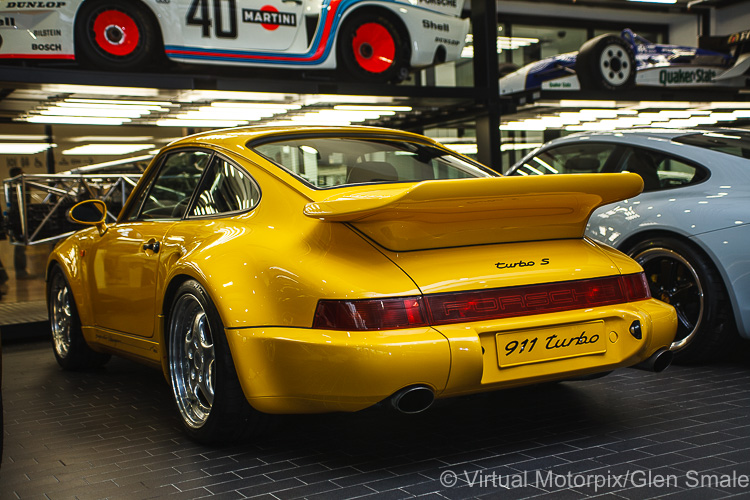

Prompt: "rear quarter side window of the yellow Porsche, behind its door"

[190,156,260,217]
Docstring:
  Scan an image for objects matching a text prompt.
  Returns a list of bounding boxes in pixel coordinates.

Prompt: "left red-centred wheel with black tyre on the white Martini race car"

[75,0,164,71]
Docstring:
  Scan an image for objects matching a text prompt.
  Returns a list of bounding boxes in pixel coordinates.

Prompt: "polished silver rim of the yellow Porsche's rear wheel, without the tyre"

[169,293,216,428]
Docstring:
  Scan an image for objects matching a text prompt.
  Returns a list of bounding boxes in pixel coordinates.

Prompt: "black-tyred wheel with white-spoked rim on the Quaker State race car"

[575,34,636,90]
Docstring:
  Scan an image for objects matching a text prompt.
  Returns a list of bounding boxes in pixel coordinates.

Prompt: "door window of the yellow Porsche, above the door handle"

[129,151,211,220]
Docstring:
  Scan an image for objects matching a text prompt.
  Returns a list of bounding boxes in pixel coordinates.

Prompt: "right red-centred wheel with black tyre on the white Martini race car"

[338,11,410,82]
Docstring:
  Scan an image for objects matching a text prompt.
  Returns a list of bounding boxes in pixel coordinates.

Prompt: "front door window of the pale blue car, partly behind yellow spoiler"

[514,142,617,175]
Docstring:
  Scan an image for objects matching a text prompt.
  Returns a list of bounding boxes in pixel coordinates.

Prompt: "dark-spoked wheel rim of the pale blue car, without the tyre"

[633,248,705,350]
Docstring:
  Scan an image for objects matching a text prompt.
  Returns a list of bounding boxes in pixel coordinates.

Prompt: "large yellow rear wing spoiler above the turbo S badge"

[304,173,643,251]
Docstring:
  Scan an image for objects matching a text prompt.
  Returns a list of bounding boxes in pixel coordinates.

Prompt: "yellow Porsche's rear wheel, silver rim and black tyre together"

[168,280,260,443]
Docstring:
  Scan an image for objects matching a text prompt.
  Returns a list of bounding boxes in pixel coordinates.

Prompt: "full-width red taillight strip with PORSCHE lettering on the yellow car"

[313,273,651,331]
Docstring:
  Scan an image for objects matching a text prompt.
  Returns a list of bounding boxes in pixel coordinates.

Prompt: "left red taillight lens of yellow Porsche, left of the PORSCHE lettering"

[313,297,427,330]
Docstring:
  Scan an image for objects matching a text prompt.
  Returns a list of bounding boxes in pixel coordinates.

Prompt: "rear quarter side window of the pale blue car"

[620,148,707,192]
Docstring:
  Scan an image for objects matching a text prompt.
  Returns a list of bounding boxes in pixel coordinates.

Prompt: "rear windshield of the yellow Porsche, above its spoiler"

[250,137,498,189]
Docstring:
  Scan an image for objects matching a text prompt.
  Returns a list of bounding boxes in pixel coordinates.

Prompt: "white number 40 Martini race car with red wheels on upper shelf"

[0,0,469,81]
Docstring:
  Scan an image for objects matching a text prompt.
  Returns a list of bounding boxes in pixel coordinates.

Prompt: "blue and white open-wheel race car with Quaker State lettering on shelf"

[500,29,750,95]
